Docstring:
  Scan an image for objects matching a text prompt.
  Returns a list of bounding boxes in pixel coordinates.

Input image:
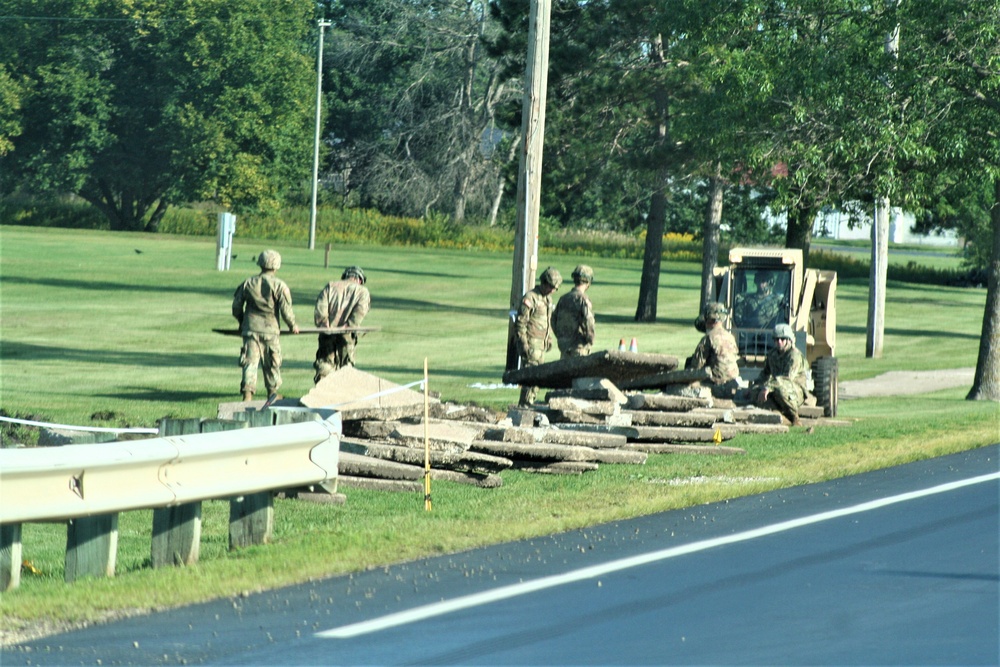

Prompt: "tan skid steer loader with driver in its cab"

[714,248,839,417]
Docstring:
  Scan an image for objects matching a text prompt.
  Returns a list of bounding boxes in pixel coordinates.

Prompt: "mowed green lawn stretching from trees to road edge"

[0,226,1000,630]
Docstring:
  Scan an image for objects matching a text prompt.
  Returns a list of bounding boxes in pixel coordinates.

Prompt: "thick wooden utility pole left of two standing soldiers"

[506,0,552,371]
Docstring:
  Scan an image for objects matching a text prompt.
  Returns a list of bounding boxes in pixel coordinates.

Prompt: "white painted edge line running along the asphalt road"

[316,472,1000,639]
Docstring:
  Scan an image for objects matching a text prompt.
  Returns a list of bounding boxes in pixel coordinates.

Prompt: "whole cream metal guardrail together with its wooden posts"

[0,411,342,590]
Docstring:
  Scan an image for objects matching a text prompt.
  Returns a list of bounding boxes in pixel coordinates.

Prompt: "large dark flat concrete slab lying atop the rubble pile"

[503,350,678,389]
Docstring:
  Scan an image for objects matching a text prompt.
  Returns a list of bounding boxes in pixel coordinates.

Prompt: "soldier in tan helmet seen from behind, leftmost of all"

[233,250,299,401]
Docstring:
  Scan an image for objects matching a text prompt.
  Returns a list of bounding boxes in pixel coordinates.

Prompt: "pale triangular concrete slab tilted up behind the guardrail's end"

[299,366,438,421]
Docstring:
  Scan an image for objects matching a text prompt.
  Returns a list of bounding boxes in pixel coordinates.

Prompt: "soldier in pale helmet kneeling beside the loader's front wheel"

[750,324,809,426]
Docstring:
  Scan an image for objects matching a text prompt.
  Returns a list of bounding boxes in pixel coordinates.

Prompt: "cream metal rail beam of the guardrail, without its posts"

[0,415,341,524]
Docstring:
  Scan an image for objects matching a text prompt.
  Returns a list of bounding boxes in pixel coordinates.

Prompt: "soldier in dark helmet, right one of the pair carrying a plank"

[313,266,371,382]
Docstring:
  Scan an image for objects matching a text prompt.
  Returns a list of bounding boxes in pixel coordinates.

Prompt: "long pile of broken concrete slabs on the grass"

[219,360,844,500]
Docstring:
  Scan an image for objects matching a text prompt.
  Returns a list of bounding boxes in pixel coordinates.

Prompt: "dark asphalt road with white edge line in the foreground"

[0,445,1000,666]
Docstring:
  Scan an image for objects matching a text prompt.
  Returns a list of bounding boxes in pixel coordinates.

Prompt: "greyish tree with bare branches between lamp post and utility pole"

[325,0,519,222]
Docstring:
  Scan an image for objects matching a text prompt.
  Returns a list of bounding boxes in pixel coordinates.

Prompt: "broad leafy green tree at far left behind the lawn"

[0,0,314,231]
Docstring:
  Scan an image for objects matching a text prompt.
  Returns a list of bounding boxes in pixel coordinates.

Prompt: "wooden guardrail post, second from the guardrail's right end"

[149,419,201,568]
